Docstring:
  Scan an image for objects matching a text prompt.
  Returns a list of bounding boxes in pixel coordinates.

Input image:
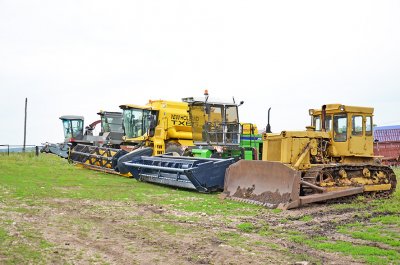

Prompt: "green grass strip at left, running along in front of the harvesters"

[0,154,263,216]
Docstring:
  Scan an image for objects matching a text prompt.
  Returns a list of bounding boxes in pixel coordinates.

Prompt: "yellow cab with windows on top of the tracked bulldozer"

[310,104,374,157]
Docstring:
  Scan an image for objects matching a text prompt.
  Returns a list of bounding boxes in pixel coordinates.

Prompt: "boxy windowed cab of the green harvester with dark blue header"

[188,101,241,146]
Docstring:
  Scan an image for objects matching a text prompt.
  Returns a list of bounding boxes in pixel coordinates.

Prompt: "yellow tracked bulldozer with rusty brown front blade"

[224,104,397,209]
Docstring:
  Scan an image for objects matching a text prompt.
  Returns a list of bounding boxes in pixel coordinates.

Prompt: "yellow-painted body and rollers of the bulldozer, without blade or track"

[262,104,390,193]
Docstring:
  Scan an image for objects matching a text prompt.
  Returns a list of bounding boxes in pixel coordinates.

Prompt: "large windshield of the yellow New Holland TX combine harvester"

[123,109,151,138]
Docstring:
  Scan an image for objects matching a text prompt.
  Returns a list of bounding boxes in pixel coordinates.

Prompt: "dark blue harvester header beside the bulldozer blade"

[123,155,235,192]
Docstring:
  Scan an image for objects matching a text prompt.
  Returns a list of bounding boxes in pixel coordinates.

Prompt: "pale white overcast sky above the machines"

[0,0,400,144]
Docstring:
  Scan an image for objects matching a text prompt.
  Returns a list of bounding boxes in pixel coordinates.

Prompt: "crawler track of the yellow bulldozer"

[302,164,397,198]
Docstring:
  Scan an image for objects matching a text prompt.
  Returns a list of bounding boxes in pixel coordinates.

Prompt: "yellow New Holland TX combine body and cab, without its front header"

[120,100,193,155]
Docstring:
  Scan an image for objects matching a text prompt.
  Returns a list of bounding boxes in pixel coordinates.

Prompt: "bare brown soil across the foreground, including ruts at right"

[0,196,376,264]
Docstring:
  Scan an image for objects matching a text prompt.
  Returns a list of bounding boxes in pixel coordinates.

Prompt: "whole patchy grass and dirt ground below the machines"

[0,154,400,264]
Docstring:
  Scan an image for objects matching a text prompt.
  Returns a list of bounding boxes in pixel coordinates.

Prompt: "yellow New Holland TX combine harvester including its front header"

[70,100,193,173]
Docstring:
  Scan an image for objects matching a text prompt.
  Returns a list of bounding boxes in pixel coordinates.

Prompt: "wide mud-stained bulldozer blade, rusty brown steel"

[224,160,301,208]
